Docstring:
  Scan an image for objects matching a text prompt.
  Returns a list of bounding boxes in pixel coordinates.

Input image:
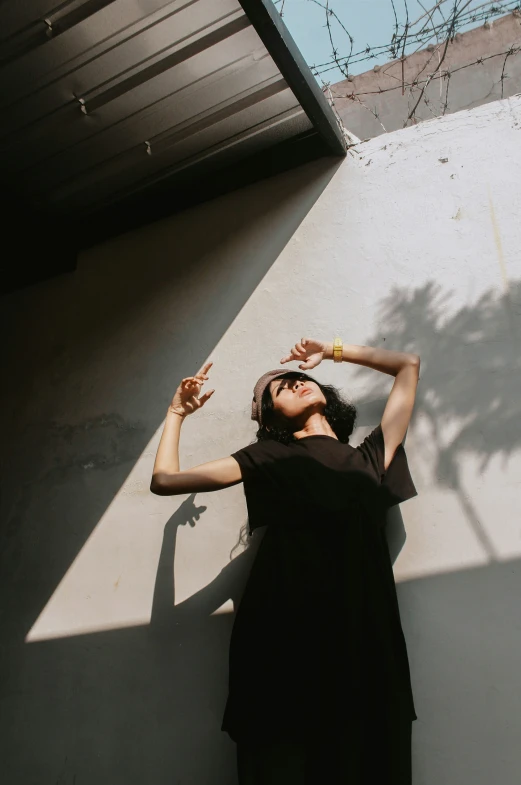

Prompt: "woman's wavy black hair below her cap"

[257,371,356,444]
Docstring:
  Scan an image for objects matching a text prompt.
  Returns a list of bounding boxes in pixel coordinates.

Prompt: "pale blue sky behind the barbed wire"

[275,0,518,82]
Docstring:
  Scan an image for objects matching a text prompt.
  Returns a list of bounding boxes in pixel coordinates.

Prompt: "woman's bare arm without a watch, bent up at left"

[150,363,242,496]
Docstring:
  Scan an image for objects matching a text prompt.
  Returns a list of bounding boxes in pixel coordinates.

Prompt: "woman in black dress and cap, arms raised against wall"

[151,338,420,785]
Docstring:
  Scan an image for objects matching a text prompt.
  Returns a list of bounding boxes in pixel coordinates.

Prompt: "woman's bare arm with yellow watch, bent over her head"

[281,338,420,469]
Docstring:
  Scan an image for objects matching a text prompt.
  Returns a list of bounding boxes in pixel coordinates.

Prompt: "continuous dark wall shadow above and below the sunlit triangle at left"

[0,159,339,785]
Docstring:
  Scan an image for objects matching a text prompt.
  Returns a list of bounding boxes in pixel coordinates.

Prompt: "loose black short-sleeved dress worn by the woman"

[222,425,417,785]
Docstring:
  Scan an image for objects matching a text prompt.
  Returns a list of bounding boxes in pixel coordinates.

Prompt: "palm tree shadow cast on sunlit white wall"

[355,281,521,560]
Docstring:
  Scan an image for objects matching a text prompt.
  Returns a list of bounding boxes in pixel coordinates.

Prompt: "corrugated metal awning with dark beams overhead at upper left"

[0,0,345,288]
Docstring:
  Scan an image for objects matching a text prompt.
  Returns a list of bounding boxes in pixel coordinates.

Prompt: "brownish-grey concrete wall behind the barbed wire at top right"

[331,11,521,139]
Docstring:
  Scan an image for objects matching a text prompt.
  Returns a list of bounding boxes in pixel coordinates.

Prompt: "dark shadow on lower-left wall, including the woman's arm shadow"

[2,495,260,785]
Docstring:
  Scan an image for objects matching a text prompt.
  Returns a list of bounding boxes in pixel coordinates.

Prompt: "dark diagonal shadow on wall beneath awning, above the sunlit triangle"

[0,159,338,641]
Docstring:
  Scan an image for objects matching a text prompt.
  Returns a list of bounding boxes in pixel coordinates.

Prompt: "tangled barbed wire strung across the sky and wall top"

[275,0,521,131]
